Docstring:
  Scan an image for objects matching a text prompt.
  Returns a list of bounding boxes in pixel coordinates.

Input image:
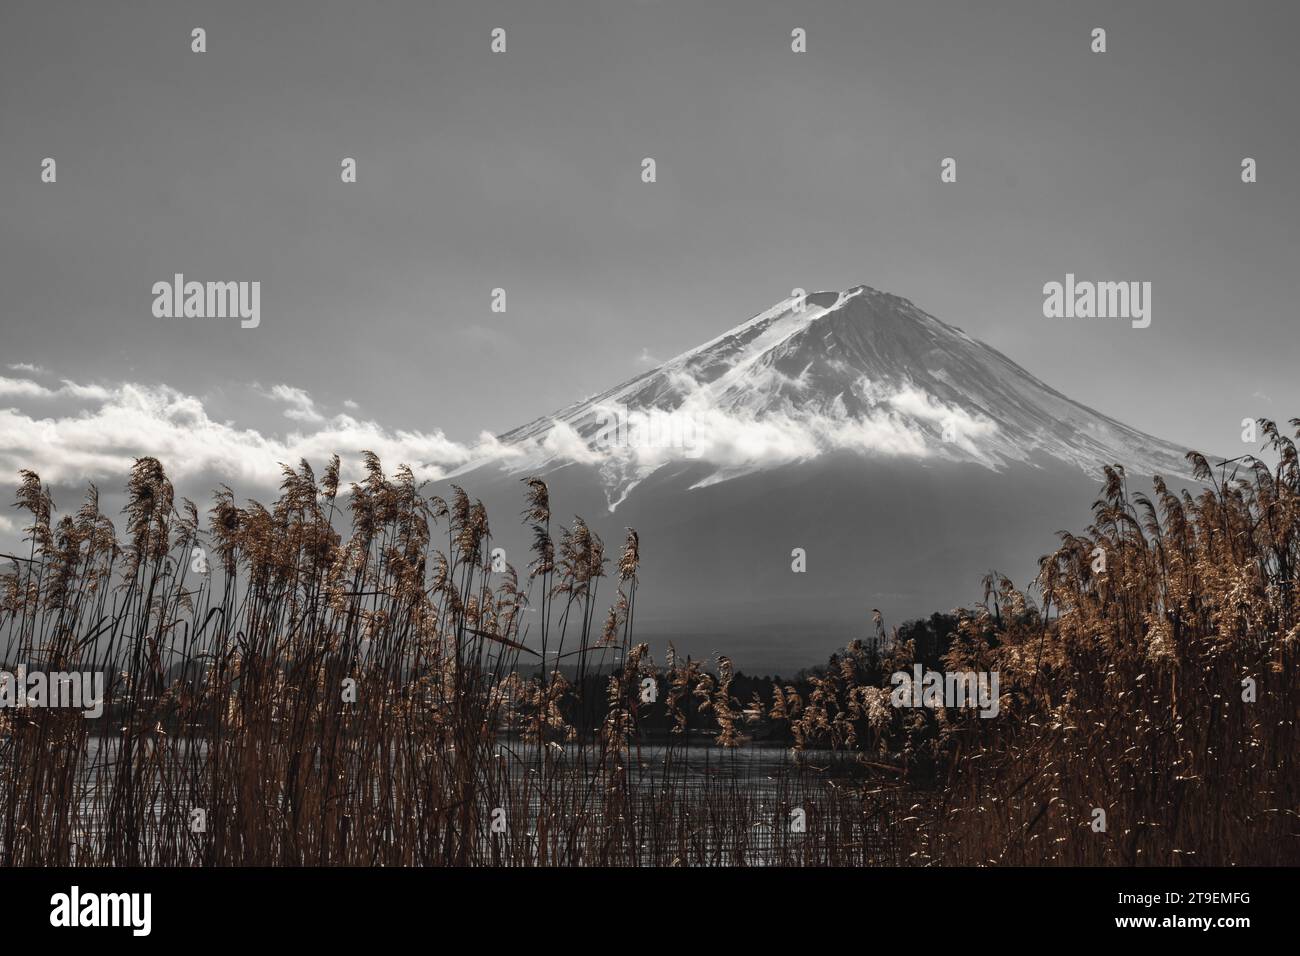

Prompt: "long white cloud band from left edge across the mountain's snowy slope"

[0,367,997,515]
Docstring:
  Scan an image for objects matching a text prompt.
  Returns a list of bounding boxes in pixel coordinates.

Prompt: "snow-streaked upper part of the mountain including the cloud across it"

[467,286,1188,510]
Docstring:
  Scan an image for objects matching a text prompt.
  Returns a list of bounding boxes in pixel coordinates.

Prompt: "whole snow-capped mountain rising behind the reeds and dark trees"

[454,286,1190,672]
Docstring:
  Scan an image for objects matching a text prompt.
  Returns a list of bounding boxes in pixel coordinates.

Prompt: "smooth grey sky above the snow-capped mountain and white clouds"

[0,0,1300,512]
